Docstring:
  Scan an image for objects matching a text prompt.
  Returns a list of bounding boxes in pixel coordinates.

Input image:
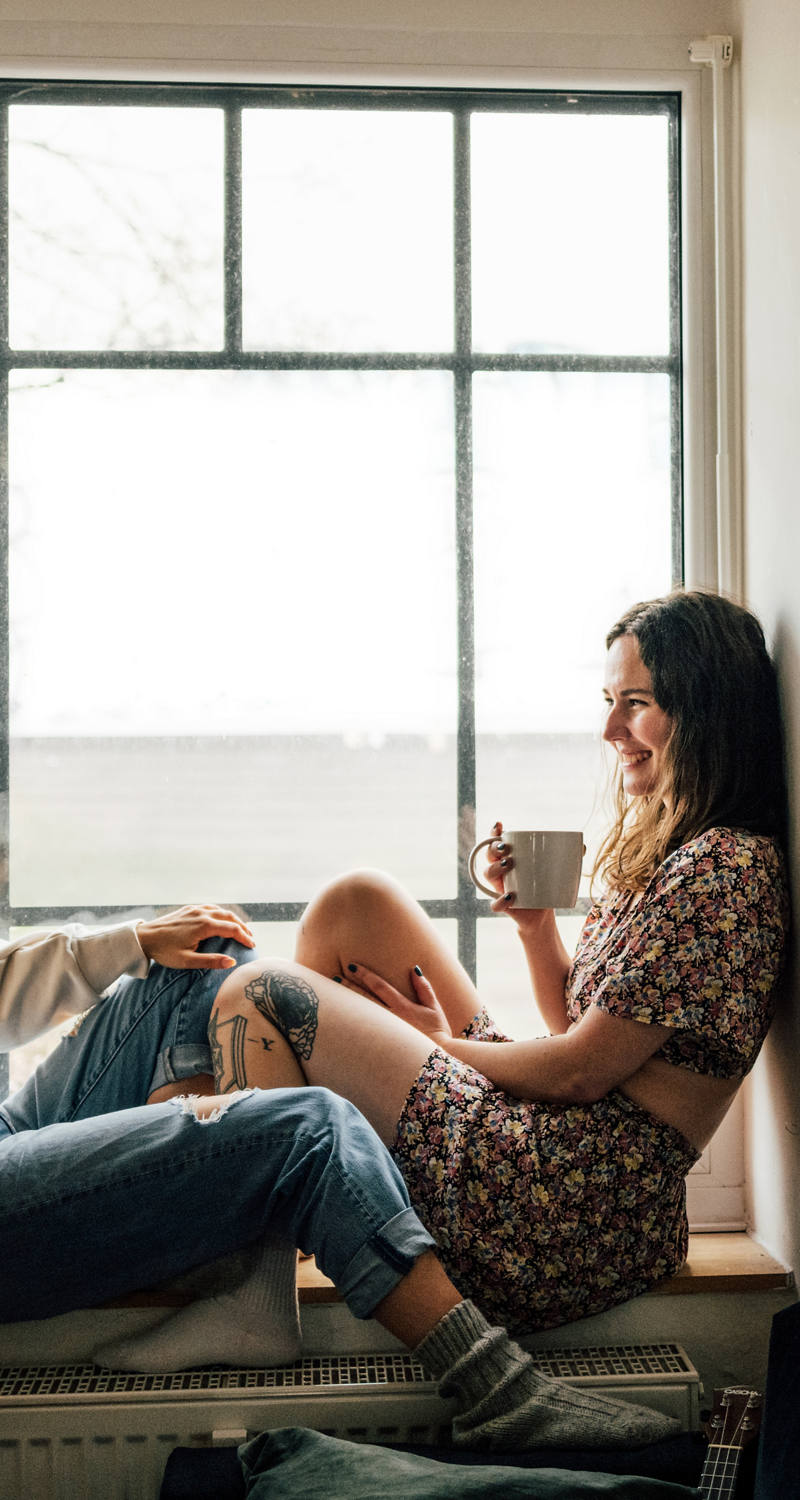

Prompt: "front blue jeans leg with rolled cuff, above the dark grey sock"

[0,1089,434,1322]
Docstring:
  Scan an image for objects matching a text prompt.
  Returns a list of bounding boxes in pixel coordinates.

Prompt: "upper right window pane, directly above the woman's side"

[471,114,669,354]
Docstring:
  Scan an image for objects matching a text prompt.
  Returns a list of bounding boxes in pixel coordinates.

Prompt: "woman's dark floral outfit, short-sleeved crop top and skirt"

[393,828,788,1332]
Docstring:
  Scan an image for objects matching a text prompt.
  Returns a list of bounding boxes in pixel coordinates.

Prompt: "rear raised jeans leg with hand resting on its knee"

[0,938,257,1133]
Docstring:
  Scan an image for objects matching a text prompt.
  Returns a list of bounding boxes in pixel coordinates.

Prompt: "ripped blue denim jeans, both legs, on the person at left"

[0,950,434,1322]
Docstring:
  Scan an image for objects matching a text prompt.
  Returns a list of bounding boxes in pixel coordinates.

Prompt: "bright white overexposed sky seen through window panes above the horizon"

[11,105,669,738]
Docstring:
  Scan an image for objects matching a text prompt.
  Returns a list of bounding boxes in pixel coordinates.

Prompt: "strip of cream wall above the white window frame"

[0,0,734,84]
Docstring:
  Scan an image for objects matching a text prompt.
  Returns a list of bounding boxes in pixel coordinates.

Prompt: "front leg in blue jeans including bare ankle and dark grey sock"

[20,1089,675,1449]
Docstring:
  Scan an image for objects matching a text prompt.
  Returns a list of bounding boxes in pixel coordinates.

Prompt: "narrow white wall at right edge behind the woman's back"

[737,0,800,1269]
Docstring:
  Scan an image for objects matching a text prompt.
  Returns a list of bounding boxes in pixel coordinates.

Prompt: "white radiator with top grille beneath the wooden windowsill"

[0,1344,699,1500]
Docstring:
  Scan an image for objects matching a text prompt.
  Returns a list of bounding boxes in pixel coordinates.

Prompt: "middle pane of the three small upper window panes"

[242,110,453,351]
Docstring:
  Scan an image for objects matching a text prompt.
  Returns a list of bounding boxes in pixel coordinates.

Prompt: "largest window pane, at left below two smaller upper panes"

[11,372,456,906]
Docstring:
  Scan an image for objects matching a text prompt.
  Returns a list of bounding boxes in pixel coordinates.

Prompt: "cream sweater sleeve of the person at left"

[0,923,150,1052]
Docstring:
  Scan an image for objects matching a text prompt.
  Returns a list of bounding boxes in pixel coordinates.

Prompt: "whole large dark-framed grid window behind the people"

[0,84,683,1086]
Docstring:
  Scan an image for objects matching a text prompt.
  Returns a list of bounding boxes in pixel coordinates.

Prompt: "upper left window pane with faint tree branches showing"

[9,105,222,350]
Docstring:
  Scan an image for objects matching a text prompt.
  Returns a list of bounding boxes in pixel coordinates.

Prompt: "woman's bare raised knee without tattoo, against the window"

[294,870,480,1035]
